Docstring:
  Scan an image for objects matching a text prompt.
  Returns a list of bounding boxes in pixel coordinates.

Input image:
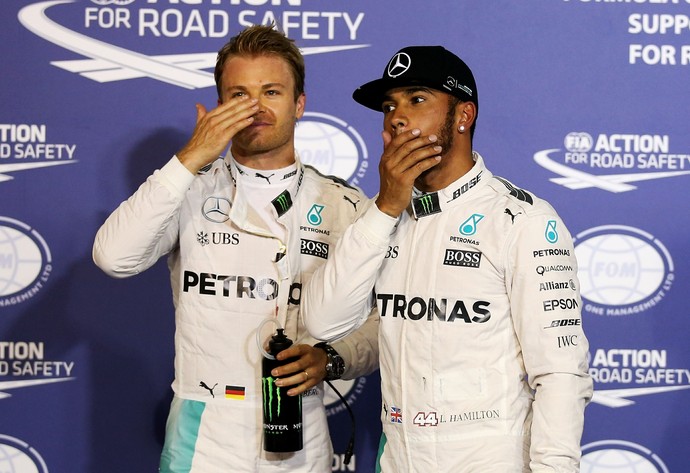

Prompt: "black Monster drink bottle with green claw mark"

[261,328,302,452]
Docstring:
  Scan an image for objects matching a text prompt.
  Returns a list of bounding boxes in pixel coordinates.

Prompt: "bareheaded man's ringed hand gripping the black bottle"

[271,345,326,396]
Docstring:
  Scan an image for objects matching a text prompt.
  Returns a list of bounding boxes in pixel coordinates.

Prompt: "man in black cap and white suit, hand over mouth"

[302,46,592,473]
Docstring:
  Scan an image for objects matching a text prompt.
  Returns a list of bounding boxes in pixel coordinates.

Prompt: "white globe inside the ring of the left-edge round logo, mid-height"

[0,220,43,296]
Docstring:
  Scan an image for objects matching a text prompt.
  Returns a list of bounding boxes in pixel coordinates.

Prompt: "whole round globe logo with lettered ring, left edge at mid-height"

[0,217,53,307]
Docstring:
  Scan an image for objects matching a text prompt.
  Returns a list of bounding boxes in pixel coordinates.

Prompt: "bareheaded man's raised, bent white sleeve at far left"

[92,156,195,278]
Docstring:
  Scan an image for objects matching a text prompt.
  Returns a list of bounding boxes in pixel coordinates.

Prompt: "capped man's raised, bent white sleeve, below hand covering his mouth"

[300,199,397,341]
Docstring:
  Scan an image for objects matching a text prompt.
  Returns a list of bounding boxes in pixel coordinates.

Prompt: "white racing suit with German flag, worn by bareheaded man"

[93,153,378,473]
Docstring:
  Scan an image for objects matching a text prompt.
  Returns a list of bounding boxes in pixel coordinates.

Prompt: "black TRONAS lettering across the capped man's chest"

[376,294,491,324]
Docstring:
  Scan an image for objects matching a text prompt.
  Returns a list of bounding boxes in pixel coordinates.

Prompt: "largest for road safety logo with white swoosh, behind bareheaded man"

[18,0,369,89]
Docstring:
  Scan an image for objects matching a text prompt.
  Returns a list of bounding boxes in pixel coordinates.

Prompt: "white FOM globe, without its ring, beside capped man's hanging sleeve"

[575,233,666,305]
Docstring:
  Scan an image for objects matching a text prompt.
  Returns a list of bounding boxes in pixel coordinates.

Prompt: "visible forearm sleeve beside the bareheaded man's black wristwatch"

[331,307,379,379]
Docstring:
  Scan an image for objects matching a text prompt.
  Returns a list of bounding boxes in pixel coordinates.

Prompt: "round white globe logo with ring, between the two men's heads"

[295,112,369,186]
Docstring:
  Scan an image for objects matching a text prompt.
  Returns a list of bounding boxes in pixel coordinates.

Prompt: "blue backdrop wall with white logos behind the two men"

[0,0,690,473]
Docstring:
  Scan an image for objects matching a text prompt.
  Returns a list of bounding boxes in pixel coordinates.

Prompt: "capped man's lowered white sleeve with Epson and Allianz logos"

[506,213,592,473]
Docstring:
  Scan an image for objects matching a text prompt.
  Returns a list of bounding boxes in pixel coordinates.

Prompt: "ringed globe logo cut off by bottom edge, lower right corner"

[580,440,669,473]
